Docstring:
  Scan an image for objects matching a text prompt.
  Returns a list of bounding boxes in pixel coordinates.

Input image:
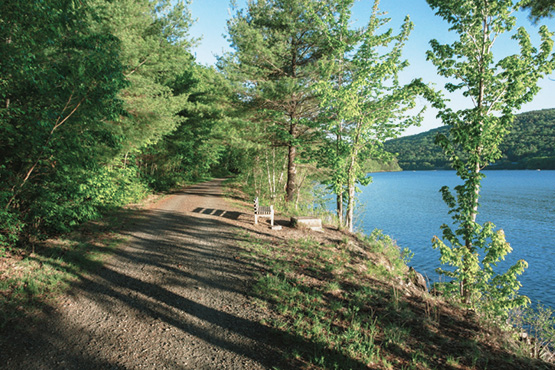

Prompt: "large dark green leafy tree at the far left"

[0,0,125,244]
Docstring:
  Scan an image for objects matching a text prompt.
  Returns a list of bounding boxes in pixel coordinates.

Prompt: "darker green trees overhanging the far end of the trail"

[140,66,238,190]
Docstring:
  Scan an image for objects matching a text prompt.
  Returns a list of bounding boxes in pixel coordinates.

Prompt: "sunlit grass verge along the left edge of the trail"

[0,210,130,329]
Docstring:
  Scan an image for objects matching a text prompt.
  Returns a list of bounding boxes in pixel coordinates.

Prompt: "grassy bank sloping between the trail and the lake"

[241,232,550,369]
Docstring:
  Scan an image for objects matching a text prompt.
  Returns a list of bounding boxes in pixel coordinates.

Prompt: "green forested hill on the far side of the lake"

[385,109,555,170]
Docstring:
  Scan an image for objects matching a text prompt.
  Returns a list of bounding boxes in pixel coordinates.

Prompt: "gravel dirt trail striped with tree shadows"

[4,180,288,369]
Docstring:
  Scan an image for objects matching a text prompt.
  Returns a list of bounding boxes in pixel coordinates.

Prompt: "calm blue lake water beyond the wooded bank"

[357,171,555,308]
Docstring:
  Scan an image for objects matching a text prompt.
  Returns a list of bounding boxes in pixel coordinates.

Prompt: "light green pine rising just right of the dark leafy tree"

[97,0,197,154]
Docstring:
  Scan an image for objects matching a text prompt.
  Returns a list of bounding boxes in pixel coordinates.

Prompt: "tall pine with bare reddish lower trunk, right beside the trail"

[220,0,333,202]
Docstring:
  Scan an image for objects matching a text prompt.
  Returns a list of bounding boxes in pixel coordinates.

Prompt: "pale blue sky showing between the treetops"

[190,0,555,136]
